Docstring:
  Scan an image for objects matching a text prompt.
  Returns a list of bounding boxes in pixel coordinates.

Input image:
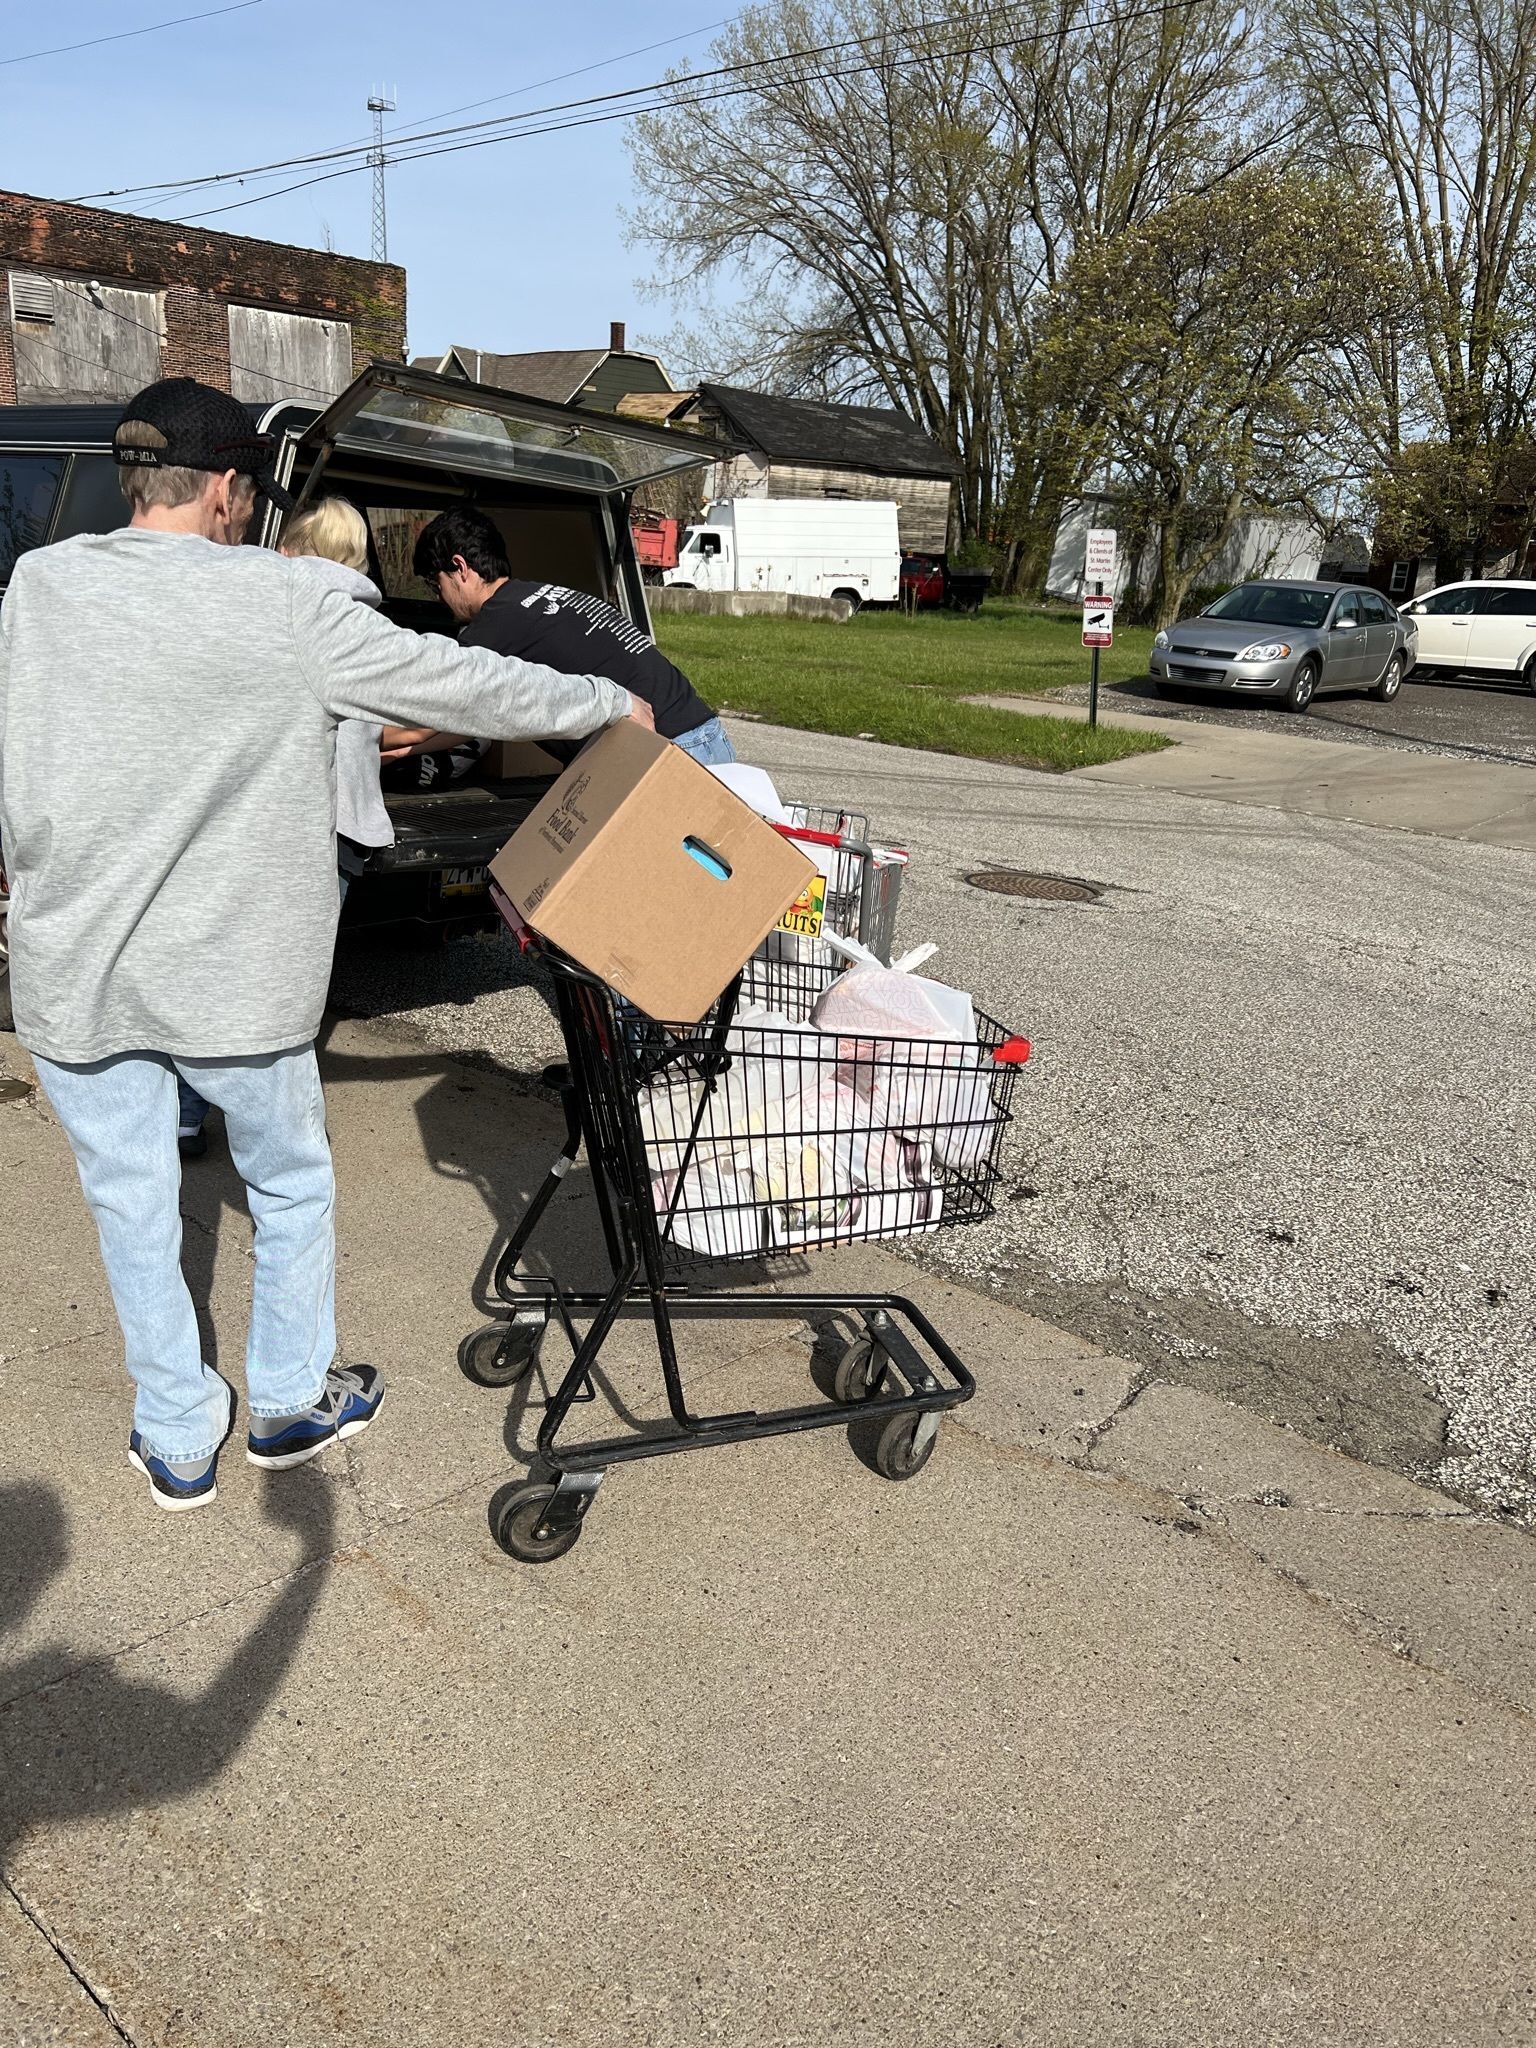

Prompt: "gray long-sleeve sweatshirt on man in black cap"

[0,526,629,1063]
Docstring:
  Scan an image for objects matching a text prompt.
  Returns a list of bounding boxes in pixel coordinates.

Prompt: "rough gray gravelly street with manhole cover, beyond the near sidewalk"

[336,727,1536,1522]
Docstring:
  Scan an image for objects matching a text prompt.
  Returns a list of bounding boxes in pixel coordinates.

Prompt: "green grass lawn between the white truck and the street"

[655,598,1167,768]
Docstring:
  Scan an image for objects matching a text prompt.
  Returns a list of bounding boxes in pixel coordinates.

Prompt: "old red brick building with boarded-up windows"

[0,193,406,406]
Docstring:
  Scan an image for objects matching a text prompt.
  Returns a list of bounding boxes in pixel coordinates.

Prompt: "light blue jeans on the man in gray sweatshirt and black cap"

[35,1044,336,1462]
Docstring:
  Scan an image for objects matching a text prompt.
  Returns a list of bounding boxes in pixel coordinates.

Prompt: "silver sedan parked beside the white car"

[1151,578,1417,711]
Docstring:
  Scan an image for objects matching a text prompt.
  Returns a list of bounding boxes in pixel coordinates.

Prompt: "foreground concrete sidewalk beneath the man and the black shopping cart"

[0,1026,1536,2048]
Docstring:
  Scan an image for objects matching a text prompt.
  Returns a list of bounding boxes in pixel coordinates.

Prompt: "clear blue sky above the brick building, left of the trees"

[0,0,733,354]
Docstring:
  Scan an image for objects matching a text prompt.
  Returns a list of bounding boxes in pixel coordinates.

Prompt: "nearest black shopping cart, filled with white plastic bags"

[461,899,1028,1563]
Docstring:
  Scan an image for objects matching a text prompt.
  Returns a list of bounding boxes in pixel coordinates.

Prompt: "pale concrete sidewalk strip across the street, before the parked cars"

[965,696,1536,852]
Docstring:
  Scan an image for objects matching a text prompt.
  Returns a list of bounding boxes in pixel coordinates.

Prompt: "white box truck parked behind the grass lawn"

[662,498,901,606]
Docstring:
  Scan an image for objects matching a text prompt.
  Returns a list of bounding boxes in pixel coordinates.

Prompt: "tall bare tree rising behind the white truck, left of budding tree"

[631,0,1260,575]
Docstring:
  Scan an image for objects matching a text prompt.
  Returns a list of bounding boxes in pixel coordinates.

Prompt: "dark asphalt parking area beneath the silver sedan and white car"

[1051,676,1536,764]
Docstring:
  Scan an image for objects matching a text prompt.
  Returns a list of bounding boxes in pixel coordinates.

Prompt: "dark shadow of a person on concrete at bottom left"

[0,1466,336,1870]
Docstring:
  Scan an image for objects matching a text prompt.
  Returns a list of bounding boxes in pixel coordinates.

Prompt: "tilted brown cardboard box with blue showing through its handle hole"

[492,719,817,1024]
